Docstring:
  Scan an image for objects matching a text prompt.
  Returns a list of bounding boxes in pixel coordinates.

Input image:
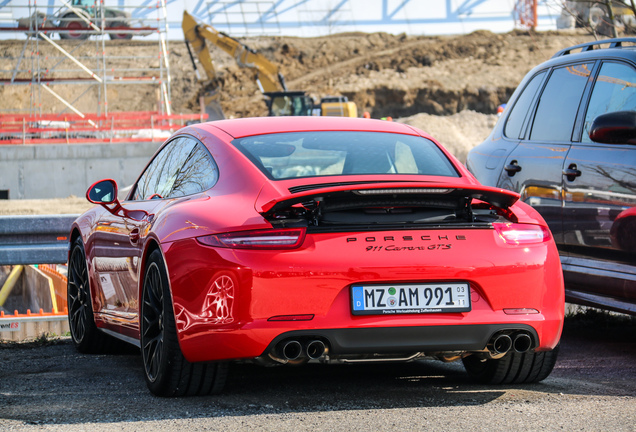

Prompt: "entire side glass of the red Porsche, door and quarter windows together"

[133,137,218,200]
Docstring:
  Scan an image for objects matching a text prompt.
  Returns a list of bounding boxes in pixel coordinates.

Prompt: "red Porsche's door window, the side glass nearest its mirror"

[133,137,196,200]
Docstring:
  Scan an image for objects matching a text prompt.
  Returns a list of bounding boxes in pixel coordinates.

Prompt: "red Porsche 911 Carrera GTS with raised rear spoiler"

[68,117,564,396]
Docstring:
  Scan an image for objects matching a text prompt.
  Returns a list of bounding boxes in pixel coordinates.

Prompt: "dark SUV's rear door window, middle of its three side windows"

[530,63,594,141]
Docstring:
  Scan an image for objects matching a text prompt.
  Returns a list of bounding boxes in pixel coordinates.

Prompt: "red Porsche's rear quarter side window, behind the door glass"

[168,138,219,198]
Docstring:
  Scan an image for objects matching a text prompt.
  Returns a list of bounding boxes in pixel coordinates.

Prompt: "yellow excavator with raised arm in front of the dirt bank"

[181,11,358,120]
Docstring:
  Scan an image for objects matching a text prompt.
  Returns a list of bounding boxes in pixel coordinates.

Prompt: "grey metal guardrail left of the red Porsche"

[0,215,79,265]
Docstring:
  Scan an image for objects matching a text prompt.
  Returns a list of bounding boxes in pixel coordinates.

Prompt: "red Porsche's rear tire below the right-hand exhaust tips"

[462,346,559,384]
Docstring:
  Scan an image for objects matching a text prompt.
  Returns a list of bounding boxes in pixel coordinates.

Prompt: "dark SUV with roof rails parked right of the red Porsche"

[466,38,636,315]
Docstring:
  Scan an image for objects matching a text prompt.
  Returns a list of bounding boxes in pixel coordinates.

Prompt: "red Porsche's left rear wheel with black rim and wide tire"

[140,250,228,397]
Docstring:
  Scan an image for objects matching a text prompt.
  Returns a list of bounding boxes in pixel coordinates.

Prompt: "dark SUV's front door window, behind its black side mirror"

[581,63,636,143]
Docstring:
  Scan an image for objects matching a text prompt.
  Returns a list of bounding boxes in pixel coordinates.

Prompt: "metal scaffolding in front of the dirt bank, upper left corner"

[0,0,172,139]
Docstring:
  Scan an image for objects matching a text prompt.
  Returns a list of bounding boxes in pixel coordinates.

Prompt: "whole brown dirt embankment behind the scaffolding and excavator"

[0,31,591,118]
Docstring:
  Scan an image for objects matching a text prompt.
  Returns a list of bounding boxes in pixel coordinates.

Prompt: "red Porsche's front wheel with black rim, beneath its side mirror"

[66,237,121,354]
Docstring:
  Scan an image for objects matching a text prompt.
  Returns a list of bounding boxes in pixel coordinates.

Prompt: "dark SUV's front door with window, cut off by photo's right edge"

[562,61,636,301]
